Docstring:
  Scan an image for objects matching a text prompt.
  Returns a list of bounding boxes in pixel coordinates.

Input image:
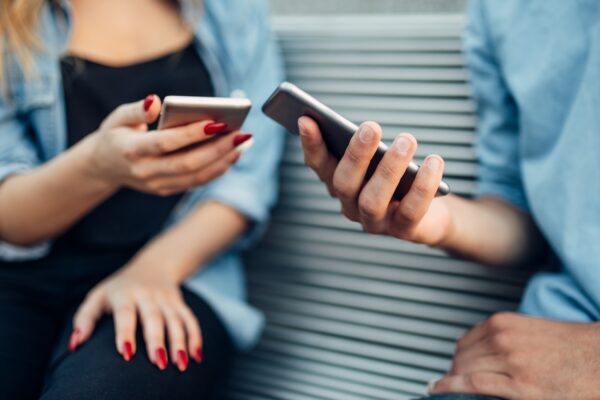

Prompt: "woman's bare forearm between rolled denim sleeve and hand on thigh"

[126,202,248,282]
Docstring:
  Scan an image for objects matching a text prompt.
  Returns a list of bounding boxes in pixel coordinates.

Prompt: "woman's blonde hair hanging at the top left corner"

[0,0,46,88]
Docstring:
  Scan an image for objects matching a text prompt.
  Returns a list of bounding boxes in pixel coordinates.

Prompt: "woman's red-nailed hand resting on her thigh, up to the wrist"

[69,253,202,371]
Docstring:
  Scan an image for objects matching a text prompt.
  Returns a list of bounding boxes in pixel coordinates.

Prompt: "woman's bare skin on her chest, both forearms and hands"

[0,0,247,370]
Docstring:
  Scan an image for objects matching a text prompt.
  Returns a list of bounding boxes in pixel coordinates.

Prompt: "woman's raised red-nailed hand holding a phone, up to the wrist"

[81,96,252,196]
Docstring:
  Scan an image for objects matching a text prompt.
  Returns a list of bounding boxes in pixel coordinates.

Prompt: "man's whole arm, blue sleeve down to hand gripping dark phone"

[301,2,544,266]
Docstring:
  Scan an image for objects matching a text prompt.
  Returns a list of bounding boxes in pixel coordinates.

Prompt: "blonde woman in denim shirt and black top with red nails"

[0,0,282,400]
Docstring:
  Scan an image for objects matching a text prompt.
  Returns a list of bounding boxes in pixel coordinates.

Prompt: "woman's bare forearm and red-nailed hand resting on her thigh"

[70,202,247,371]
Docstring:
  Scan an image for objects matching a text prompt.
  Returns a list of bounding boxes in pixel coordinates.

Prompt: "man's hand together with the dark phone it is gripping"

[264,84,454,245]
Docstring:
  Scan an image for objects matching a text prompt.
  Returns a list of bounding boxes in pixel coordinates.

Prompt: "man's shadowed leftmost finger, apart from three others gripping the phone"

[298,117,338,185]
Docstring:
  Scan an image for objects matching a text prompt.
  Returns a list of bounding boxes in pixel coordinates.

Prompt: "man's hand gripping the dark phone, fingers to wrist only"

[298,117,453,246]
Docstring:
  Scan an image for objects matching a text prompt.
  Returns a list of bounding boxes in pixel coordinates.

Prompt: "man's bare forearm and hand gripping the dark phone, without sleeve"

[300,118,540,266]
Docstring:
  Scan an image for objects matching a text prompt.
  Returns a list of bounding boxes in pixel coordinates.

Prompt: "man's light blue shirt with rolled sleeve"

[465,0,600,322]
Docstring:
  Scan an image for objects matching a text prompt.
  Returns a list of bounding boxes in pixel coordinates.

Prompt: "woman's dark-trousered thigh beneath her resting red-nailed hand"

[41,289,233,400]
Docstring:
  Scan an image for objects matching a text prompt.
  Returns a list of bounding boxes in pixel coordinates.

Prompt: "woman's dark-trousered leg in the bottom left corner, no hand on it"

[0,296,57,400]
